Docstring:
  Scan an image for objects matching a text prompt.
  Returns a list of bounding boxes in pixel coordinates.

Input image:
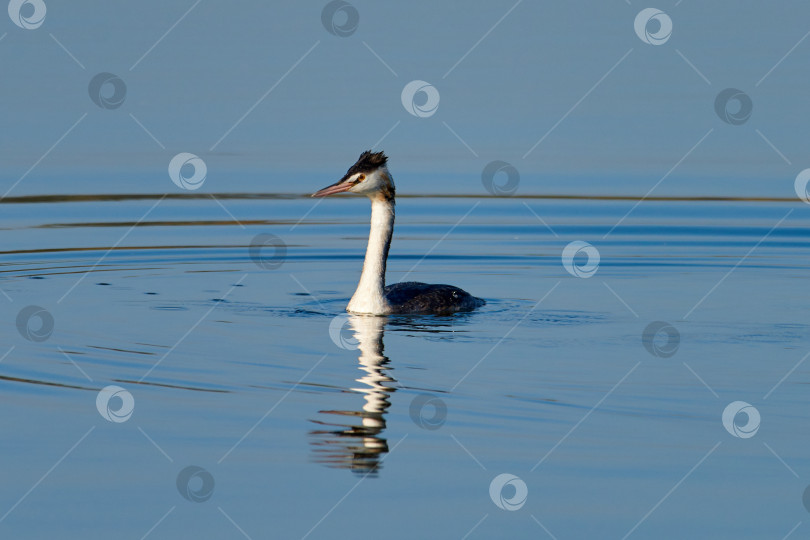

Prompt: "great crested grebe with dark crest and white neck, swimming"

[312,151,486,315]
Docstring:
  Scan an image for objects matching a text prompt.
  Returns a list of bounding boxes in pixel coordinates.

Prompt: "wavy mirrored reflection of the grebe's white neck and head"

[310,315,397,475]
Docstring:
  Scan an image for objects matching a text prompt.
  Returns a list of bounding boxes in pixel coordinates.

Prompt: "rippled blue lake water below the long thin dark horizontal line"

[0,187,810,539]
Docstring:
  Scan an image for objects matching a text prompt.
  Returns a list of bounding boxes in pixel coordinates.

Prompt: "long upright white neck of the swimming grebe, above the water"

[346,197,394,315]
